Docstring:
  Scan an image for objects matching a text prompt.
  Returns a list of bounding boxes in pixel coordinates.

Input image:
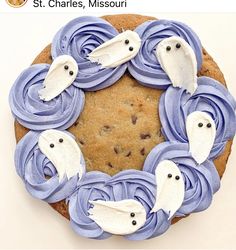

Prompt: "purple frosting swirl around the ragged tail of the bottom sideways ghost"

[67,171,111,239]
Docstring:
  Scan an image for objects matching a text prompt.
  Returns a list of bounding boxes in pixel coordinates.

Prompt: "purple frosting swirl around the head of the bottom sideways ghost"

[106,170,170,240]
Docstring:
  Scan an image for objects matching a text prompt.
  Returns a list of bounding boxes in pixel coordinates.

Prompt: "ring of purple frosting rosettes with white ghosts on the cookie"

[10,17,236,240]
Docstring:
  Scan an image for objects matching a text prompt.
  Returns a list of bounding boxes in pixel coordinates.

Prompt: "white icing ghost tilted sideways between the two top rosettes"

[88,30,141,68]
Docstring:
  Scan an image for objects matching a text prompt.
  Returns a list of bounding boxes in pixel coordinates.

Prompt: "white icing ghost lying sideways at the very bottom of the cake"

[88,199,146,235]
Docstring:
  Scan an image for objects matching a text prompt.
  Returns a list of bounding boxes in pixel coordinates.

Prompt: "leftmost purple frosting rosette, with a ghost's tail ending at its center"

[9,64,85,130]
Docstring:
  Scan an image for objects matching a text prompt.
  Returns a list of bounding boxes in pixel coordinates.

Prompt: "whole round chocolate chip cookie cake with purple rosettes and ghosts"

[9,15,236,240]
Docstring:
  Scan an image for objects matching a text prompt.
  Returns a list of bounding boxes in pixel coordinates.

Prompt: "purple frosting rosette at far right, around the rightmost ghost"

[159,77,236,158]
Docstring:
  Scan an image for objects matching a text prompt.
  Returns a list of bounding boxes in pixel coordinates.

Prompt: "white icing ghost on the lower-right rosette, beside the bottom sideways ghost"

[151,160,185,220]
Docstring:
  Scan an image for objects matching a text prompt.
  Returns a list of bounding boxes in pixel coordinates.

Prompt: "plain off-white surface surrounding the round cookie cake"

[0,12,236,249]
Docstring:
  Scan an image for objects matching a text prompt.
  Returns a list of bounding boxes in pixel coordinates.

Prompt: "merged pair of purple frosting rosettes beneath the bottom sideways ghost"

[68,170,170,240]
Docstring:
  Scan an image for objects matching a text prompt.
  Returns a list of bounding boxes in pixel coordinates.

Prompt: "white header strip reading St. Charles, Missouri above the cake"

[0,0,236,12]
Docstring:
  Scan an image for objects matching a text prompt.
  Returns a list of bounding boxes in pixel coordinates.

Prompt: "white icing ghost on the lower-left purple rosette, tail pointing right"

[38,129,85,182]
